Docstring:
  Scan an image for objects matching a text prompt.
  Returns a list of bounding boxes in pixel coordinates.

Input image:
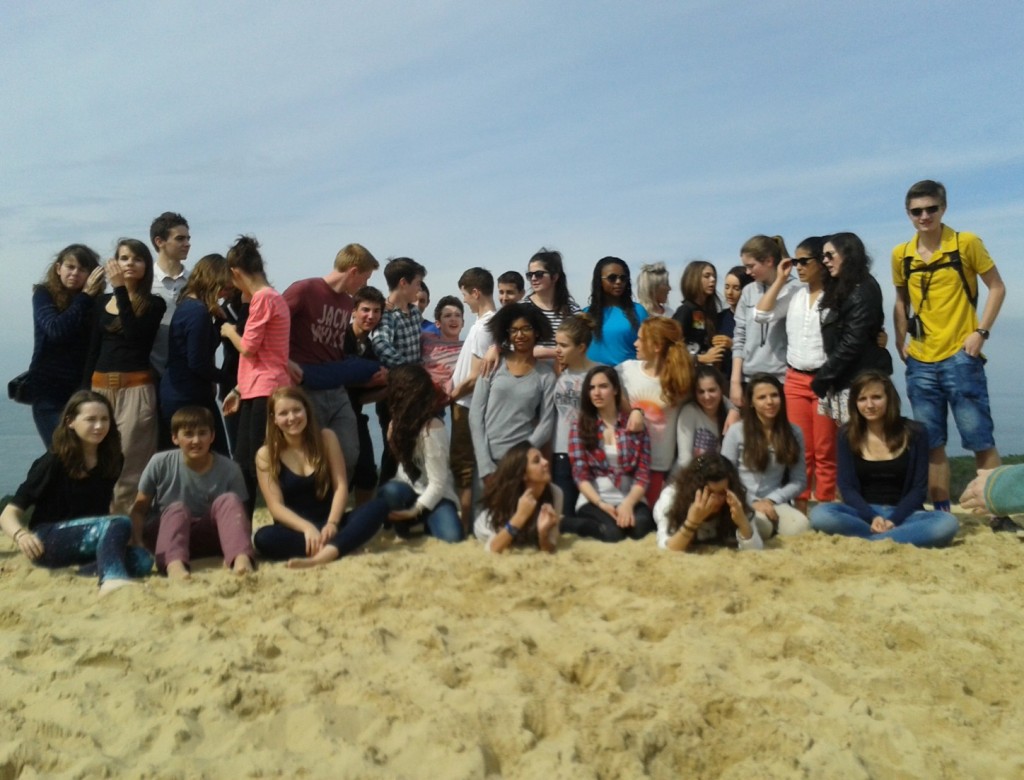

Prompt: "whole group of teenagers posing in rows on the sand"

[0,181,1012,591]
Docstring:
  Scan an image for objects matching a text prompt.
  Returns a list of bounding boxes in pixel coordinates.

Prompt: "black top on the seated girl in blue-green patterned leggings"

[11,452,117,528]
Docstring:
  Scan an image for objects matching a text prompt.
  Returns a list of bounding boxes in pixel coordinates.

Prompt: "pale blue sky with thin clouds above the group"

[0,0,1024,375]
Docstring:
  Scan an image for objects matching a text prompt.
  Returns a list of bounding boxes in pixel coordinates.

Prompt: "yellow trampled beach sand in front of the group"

[0,509,1024,779]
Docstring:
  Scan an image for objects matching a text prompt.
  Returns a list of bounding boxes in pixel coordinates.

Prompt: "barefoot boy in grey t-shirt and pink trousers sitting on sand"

[131,406,254,579]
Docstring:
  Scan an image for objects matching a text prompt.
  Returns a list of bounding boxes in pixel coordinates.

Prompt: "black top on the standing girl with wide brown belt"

[85,287,167,378]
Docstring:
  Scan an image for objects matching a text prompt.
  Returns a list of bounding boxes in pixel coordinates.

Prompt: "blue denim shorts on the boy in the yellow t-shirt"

[906,349,995,452]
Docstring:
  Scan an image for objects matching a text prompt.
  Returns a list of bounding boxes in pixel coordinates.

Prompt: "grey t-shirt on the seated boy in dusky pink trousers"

[138,449,249,519]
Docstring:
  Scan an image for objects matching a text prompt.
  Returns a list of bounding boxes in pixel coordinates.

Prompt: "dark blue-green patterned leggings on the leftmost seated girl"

[32,515,153,584]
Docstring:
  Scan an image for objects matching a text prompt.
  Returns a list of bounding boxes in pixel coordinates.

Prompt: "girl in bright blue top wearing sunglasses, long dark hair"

[587,257,648,365]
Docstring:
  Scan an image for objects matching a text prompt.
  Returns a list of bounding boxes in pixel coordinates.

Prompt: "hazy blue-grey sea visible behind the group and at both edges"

[0,325,1024,495]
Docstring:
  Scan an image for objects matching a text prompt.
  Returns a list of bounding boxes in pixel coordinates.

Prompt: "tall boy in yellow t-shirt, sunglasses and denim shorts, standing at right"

[892,179,1006,512]
